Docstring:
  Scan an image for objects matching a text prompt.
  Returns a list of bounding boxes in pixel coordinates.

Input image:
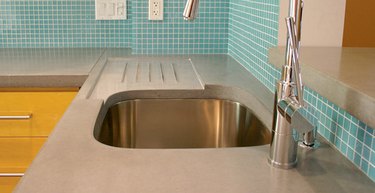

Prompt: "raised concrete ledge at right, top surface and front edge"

[269,47,375,128]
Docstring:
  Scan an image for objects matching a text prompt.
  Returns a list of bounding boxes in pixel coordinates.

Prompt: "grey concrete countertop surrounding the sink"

[1,51,375,193]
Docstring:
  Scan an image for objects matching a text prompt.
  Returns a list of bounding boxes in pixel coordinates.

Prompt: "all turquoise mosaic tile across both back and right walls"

[0,0,375,181]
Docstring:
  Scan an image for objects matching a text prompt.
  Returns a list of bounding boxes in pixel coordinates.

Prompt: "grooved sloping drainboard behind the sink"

[106,59,204,90]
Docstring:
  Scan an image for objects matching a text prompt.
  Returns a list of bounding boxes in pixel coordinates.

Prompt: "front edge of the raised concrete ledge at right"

[269,47,375,128]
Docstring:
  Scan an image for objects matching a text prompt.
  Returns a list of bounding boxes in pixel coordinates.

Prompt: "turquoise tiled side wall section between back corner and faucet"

[228,0,279,89]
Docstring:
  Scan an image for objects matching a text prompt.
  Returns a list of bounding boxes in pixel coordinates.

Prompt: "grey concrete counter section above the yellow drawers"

[0,48,105,87]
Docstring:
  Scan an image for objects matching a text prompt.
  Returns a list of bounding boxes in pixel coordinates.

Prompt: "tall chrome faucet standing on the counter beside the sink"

[268,0,315,169]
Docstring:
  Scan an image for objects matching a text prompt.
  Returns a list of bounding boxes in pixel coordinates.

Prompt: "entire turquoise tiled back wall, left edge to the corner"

[0,0,228,54]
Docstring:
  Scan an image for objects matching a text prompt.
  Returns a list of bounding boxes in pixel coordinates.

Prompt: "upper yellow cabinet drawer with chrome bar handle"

[0,89,78,137]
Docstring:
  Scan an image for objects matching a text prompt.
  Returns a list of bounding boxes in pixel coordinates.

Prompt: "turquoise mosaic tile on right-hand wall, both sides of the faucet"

[228,0,375,181]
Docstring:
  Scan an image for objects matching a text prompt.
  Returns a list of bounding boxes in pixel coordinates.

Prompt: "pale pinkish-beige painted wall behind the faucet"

[278,0,346,46]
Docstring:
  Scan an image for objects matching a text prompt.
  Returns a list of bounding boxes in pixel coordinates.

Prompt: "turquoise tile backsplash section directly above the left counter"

[0,0,132,48]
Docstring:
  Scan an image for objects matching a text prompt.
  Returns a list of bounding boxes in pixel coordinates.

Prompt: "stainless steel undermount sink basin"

[94,99,271,148]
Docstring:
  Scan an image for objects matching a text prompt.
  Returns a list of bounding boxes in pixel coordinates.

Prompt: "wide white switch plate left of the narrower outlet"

[95,0,127,20]
